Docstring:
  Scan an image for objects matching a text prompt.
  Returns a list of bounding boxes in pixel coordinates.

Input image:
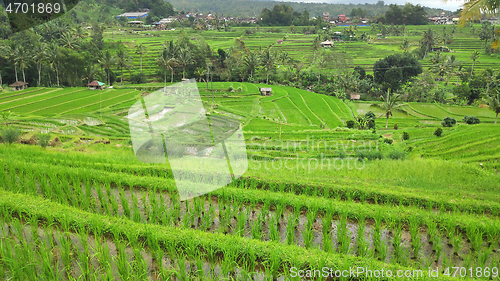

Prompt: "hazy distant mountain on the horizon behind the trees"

[170,0,450,17]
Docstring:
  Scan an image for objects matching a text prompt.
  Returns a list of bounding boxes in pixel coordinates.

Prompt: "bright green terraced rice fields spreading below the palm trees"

[0,83,500,280]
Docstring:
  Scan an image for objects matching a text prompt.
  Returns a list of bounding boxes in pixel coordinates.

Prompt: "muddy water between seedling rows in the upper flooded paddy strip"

[17,176,498,272]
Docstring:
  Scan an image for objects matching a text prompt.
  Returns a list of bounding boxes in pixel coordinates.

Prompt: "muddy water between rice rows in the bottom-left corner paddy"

[0,221,284,281]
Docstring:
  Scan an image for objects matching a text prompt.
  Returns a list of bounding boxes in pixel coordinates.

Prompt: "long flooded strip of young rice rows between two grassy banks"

[0,158,500,279]
